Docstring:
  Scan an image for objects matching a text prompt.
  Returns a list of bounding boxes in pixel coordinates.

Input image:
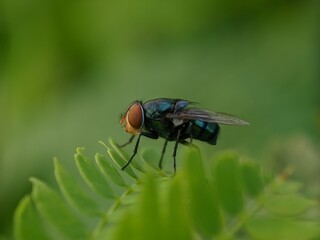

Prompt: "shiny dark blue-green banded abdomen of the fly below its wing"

[191,120,220,145]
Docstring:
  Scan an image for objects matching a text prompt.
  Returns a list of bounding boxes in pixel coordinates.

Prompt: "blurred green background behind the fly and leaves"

[0,0,320,236]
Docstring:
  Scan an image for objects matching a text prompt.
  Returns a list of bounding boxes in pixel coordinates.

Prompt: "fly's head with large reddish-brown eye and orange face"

[120,101,144,134]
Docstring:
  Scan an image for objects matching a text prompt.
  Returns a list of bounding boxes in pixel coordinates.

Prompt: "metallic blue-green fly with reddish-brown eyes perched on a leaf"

[120,98,249,172]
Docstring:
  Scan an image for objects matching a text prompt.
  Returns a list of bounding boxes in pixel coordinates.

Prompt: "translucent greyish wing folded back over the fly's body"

[167,108,249,125]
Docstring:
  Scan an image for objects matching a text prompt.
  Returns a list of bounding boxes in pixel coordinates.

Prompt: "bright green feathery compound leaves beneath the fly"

[14,141,320,240]
